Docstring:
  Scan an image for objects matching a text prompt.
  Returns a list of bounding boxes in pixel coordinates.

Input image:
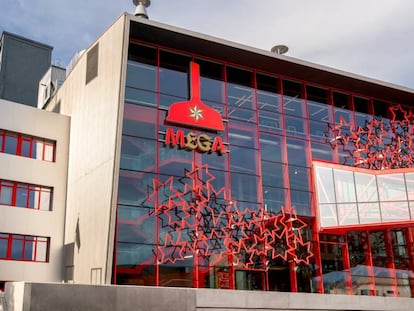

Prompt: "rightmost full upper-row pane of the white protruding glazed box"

[377,174,407,201]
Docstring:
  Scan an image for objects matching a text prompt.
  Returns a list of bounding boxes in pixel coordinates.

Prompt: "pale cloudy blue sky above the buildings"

[0,0,414,89]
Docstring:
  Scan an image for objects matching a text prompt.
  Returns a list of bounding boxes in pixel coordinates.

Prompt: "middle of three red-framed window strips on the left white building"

[0,180,53,211]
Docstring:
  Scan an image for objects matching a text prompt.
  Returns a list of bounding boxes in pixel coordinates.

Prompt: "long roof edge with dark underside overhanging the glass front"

[125,13,414,105]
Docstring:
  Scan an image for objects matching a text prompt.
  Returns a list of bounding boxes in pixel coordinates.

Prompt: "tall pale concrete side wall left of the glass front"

[47,15,127,284]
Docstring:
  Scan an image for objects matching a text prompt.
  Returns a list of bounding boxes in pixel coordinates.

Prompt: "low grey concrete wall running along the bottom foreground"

[6,283,414,311]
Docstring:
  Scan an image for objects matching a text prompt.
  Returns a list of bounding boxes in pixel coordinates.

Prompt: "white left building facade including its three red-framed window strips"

[0,100,69,289]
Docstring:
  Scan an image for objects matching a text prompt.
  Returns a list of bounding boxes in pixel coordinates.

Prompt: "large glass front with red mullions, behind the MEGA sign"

[113,39,414,296]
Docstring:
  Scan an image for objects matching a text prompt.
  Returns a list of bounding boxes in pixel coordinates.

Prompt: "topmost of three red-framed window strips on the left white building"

[0,130,56,162]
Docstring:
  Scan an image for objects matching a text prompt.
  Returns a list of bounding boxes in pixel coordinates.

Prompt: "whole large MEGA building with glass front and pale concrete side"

[39,14,414,297]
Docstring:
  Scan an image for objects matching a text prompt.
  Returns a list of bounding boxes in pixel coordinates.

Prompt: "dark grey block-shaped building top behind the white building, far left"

[0,32,53,107]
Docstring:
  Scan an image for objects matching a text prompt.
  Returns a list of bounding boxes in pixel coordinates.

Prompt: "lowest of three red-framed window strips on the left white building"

[0,233,50,262]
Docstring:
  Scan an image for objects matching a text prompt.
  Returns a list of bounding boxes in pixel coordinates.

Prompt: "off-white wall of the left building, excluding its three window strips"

[0,99,70,282]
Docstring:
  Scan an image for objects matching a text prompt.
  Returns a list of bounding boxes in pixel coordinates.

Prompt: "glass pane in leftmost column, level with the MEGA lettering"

[121,136,156,172]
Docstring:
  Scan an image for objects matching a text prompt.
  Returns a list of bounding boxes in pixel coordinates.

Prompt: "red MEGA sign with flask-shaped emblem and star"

[165,62,227,154]
